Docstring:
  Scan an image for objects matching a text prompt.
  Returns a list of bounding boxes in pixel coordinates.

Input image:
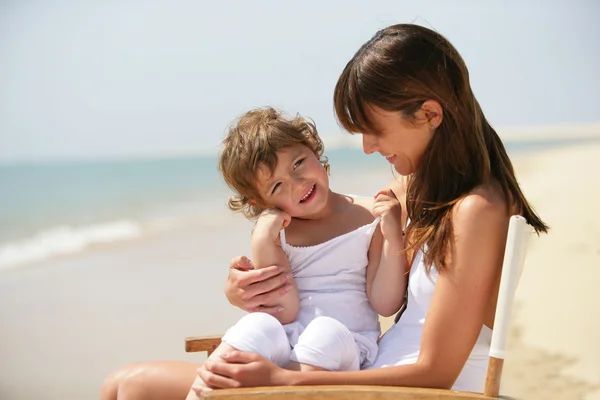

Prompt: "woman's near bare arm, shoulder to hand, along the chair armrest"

[202,193,508,388]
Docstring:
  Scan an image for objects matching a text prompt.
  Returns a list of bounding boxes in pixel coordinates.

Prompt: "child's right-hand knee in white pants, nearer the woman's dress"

[289,317,360,371]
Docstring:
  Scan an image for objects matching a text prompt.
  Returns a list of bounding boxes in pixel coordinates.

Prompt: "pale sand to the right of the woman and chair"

[504,143,600,399]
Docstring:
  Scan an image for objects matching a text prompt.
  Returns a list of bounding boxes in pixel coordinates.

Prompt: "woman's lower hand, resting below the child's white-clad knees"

[198,350,291,389]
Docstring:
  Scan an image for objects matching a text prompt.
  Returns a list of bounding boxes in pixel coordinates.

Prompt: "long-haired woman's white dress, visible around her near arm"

[365,251,492,393]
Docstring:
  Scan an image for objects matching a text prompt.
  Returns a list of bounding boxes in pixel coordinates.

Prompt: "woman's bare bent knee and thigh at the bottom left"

[100,361,201,400]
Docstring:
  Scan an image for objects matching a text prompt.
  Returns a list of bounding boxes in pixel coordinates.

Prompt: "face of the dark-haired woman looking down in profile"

[362,105,441,175]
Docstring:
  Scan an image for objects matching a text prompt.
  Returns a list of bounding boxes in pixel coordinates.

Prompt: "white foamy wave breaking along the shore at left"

[0,220,143,269]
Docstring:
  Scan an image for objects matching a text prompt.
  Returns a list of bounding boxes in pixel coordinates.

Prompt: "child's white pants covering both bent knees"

[222,312,360,371]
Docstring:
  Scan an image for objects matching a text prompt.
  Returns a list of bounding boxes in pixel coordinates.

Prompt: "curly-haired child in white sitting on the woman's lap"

[189,108,405,398]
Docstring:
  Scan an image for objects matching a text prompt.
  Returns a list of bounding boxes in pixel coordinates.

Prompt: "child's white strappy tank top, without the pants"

[280,218,381,363]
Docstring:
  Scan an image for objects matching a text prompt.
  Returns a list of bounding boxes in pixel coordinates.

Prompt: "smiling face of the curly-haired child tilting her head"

[256,144,329,218]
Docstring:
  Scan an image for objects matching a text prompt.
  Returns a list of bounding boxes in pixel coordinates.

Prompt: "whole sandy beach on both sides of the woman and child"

[0,135,600,400]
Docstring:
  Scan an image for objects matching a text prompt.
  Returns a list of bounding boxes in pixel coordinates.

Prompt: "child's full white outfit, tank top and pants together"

[223,218,381,371]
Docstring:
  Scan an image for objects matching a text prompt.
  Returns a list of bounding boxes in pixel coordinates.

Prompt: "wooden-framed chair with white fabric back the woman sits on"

[185,215,532,400]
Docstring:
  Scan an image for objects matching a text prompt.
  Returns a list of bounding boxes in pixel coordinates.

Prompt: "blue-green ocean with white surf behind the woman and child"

[0,136,592,270]
